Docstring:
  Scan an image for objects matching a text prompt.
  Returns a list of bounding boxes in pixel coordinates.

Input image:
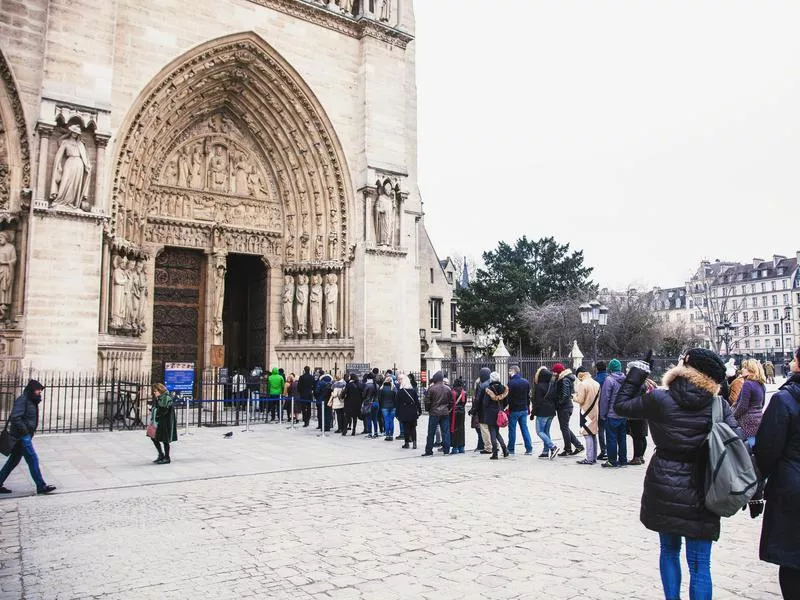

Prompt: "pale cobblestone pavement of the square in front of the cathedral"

[0,419,780,600]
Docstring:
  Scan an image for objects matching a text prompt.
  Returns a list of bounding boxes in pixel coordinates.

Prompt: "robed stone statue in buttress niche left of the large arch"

[50,125,92,211]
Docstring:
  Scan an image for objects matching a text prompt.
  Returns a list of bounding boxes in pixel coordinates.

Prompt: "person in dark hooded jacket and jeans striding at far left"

[0,379,56,494]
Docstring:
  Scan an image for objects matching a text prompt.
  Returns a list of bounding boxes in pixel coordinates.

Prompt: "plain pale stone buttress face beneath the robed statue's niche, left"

[23,205,103,373]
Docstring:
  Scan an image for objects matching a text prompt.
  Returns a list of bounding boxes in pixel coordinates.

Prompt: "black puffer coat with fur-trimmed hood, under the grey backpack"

[620,365,744,541]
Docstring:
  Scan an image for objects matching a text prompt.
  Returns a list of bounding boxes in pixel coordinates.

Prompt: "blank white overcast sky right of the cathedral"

[415,0,800,288]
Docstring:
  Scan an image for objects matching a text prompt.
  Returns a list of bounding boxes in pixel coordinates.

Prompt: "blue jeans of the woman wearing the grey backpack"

[658,533,711,600]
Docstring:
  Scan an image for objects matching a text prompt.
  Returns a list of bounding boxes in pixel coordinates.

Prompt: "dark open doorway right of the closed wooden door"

[222,254,268,372]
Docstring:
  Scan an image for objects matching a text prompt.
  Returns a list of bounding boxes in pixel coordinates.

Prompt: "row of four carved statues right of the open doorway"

[283,273,339,337]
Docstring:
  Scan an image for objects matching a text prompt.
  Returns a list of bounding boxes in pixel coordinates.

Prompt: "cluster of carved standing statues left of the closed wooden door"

[109,254,147,336]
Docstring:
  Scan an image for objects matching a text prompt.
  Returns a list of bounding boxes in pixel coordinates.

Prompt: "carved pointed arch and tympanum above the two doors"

[107,32,354,265]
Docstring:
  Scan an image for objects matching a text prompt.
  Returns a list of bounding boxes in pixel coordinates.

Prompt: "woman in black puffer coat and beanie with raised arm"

[614,348,744,600]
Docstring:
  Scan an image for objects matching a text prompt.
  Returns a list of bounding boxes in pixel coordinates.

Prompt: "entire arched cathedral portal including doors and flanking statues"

[101,33,353,372]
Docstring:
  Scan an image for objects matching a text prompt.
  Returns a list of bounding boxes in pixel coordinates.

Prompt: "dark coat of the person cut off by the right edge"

[756,373,800,569]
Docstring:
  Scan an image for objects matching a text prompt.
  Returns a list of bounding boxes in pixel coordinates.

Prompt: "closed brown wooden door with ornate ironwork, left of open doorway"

[152,247,206,381]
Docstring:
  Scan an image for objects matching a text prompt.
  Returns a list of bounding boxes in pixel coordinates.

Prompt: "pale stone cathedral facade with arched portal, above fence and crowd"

[0,0,422,377]
